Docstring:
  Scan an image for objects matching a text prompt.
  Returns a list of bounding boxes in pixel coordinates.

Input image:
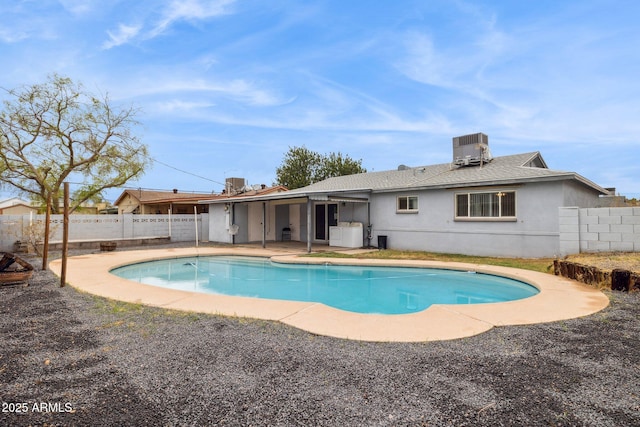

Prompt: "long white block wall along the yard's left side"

[0,214,209,251]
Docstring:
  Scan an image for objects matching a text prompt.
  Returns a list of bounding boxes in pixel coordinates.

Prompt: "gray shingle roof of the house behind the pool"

[292,152,606,193]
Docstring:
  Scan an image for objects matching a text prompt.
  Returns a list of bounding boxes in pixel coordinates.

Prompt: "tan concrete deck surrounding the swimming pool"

[49,247,609,342]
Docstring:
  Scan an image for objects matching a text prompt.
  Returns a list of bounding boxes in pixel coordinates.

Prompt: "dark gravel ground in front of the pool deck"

[0,252,640,426]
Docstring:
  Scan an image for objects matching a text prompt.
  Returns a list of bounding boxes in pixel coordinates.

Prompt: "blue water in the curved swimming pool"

[111,256,538,314]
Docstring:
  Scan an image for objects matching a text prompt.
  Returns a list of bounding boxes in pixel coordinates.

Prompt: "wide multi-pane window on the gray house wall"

[455,191,516,219]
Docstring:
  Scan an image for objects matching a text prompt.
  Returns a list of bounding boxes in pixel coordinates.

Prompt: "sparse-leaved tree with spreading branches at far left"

[0,74,150,213]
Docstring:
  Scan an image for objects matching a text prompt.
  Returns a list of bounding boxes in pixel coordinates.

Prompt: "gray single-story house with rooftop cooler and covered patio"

[200,133,609,257]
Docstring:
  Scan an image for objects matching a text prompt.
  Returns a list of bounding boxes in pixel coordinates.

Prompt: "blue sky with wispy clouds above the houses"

[0,0,640,201]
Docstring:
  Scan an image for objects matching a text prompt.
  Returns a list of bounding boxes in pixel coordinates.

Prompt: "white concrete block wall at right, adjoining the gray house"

[559,207,640,256]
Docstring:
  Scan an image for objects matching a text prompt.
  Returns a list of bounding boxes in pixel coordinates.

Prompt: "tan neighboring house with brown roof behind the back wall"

[114,189,214,214]
